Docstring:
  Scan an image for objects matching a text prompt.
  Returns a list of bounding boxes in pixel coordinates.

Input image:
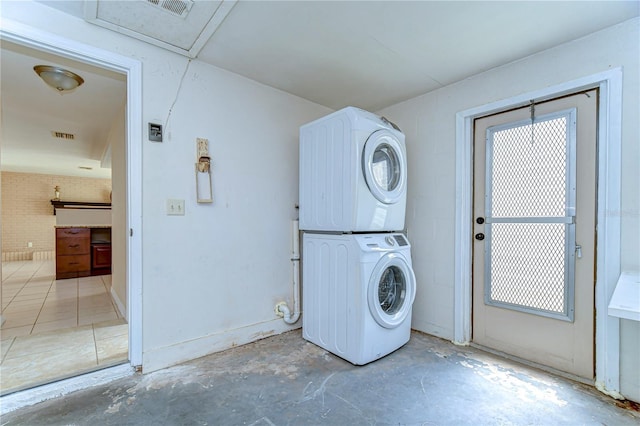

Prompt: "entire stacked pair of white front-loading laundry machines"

[299,107,416,365]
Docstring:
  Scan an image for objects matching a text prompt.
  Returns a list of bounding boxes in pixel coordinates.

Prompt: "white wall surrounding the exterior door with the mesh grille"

[380,18,640,401]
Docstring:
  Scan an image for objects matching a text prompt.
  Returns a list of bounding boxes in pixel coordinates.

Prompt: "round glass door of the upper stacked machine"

[362,130,407,204]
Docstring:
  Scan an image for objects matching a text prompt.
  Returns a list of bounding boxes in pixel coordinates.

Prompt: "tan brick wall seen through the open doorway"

[1,172,111,260]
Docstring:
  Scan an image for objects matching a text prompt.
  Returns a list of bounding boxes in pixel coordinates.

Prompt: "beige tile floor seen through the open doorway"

[0,260,129,395]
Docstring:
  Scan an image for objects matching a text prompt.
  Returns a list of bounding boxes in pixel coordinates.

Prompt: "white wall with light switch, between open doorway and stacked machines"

[2,1,331,371]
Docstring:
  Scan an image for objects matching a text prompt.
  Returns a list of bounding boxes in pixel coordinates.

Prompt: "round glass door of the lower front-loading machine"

[368,253,416,328]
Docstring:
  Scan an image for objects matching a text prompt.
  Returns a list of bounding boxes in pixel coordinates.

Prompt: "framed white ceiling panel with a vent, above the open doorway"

[84,0,237,58]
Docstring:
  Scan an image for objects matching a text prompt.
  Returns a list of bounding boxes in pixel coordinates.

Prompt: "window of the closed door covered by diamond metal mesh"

[484,110,575,320]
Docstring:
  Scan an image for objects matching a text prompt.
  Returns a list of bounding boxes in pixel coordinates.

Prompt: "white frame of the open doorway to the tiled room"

[0,19,142,367]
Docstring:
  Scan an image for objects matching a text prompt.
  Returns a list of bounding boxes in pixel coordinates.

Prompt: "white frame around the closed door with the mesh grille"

[453,68,624,399]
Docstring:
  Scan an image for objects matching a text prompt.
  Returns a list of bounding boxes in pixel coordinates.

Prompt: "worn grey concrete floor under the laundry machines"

[1,330,640,426]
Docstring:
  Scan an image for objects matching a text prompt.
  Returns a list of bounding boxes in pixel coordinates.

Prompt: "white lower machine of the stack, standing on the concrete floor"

[302,233,416,365]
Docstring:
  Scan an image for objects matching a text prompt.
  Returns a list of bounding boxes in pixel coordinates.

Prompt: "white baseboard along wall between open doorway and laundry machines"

[142,318,302,373]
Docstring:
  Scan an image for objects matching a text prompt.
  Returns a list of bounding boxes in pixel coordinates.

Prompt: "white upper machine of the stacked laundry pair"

[299,107,407,232]
